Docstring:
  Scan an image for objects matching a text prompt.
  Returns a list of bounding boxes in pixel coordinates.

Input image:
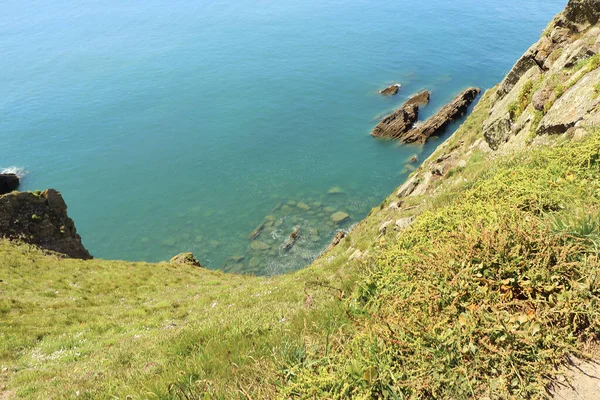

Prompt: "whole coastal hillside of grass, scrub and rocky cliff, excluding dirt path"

[0,0,600,400]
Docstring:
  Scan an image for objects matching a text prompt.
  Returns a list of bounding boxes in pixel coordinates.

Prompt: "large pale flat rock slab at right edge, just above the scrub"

[537,69,600,135]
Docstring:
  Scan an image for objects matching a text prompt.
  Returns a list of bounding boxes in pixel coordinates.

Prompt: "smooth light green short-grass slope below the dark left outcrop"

[0,241,350,399]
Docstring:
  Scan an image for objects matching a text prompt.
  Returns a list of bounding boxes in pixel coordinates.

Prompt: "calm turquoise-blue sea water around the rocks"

[0,0,566,274]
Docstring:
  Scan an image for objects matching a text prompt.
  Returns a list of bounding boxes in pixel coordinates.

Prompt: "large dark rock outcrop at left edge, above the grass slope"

[0,189,92,260]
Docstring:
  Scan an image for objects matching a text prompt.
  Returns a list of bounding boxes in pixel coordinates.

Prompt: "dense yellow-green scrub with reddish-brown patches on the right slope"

[283,132,600,399]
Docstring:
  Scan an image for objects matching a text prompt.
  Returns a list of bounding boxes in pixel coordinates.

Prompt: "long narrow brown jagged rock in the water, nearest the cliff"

[397,87,481,143]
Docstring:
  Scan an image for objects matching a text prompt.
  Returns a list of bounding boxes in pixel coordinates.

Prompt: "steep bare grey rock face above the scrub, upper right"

[483,0,600,150]
